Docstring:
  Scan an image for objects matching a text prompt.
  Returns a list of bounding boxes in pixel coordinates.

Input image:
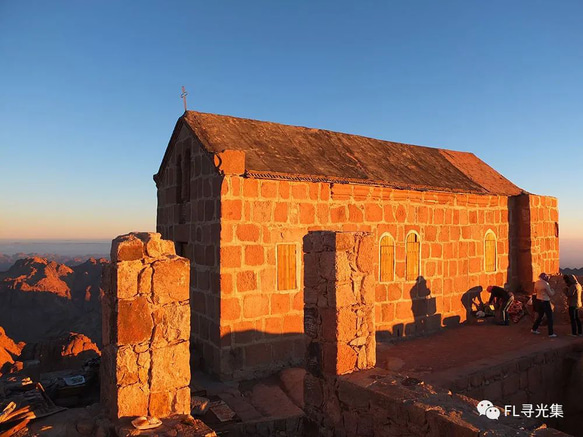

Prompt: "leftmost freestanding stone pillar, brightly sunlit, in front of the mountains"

[101,233,190,419]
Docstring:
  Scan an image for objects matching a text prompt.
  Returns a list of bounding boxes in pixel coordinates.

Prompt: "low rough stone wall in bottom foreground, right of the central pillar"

[305,368,567,437]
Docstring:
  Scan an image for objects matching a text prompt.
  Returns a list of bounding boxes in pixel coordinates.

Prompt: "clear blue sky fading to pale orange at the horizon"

[0,0,583,265]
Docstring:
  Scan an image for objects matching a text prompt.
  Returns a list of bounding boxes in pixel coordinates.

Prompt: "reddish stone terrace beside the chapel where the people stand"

[377,317,583,435]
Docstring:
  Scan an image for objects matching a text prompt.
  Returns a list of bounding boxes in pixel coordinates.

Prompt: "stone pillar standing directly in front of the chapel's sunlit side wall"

[304,231,376,375]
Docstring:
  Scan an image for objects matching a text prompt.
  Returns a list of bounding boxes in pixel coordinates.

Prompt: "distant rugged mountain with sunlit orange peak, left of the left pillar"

[0,257,108,345]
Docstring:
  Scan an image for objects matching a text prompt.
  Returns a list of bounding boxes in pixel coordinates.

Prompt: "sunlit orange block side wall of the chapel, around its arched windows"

[219,175,509,378]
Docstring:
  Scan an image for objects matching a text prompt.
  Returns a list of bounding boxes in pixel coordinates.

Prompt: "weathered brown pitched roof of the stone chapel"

[168,111,523,195]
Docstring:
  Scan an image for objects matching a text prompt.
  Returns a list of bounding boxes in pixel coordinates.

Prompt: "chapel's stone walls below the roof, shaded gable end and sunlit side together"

[155,111,559,379]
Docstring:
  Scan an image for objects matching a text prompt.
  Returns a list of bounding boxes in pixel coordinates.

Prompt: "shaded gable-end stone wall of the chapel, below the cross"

[156,126,222,371]
